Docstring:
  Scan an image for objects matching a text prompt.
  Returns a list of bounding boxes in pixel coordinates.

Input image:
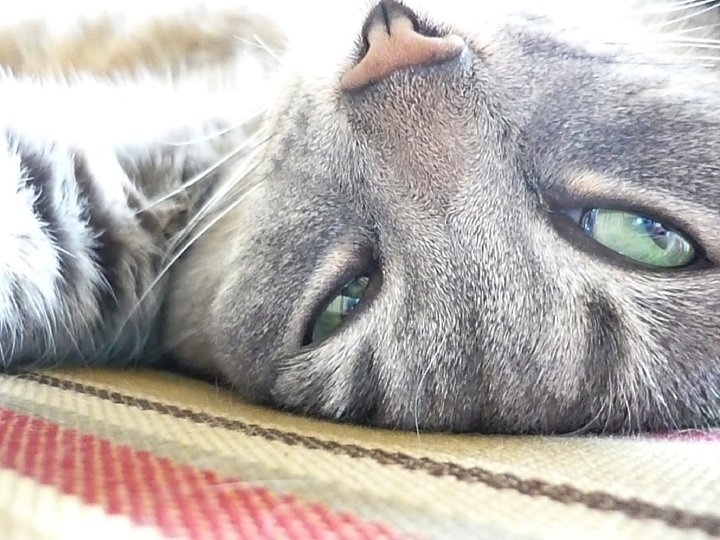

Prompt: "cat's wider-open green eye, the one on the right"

[580,208,695,268]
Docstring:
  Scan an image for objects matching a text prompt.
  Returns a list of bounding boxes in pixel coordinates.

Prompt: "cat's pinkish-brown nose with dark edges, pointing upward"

[340,0,464,92]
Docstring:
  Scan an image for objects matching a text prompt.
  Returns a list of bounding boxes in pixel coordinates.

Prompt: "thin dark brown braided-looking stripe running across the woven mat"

[18,373,720,537]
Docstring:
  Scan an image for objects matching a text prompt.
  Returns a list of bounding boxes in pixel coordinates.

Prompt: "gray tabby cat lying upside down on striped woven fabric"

[0,0,720,433]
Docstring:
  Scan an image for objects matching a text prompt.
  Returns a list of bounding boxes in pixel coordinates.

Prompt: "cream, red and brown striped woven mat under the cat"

[0,370,720,540]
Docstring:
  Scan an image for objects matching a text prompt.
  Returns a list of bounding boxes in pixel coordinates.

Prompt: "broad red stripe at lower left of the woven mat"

[0,408,414,540]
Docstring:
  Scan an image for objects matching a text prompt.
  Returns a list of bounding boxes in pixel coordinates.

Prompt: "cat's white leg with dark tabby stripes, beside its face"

[0,131,166,367]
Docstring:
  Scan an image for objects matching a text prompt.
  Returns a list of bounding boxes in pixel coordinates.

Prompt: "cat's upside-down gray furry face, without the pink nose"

[169,2,720,432]
